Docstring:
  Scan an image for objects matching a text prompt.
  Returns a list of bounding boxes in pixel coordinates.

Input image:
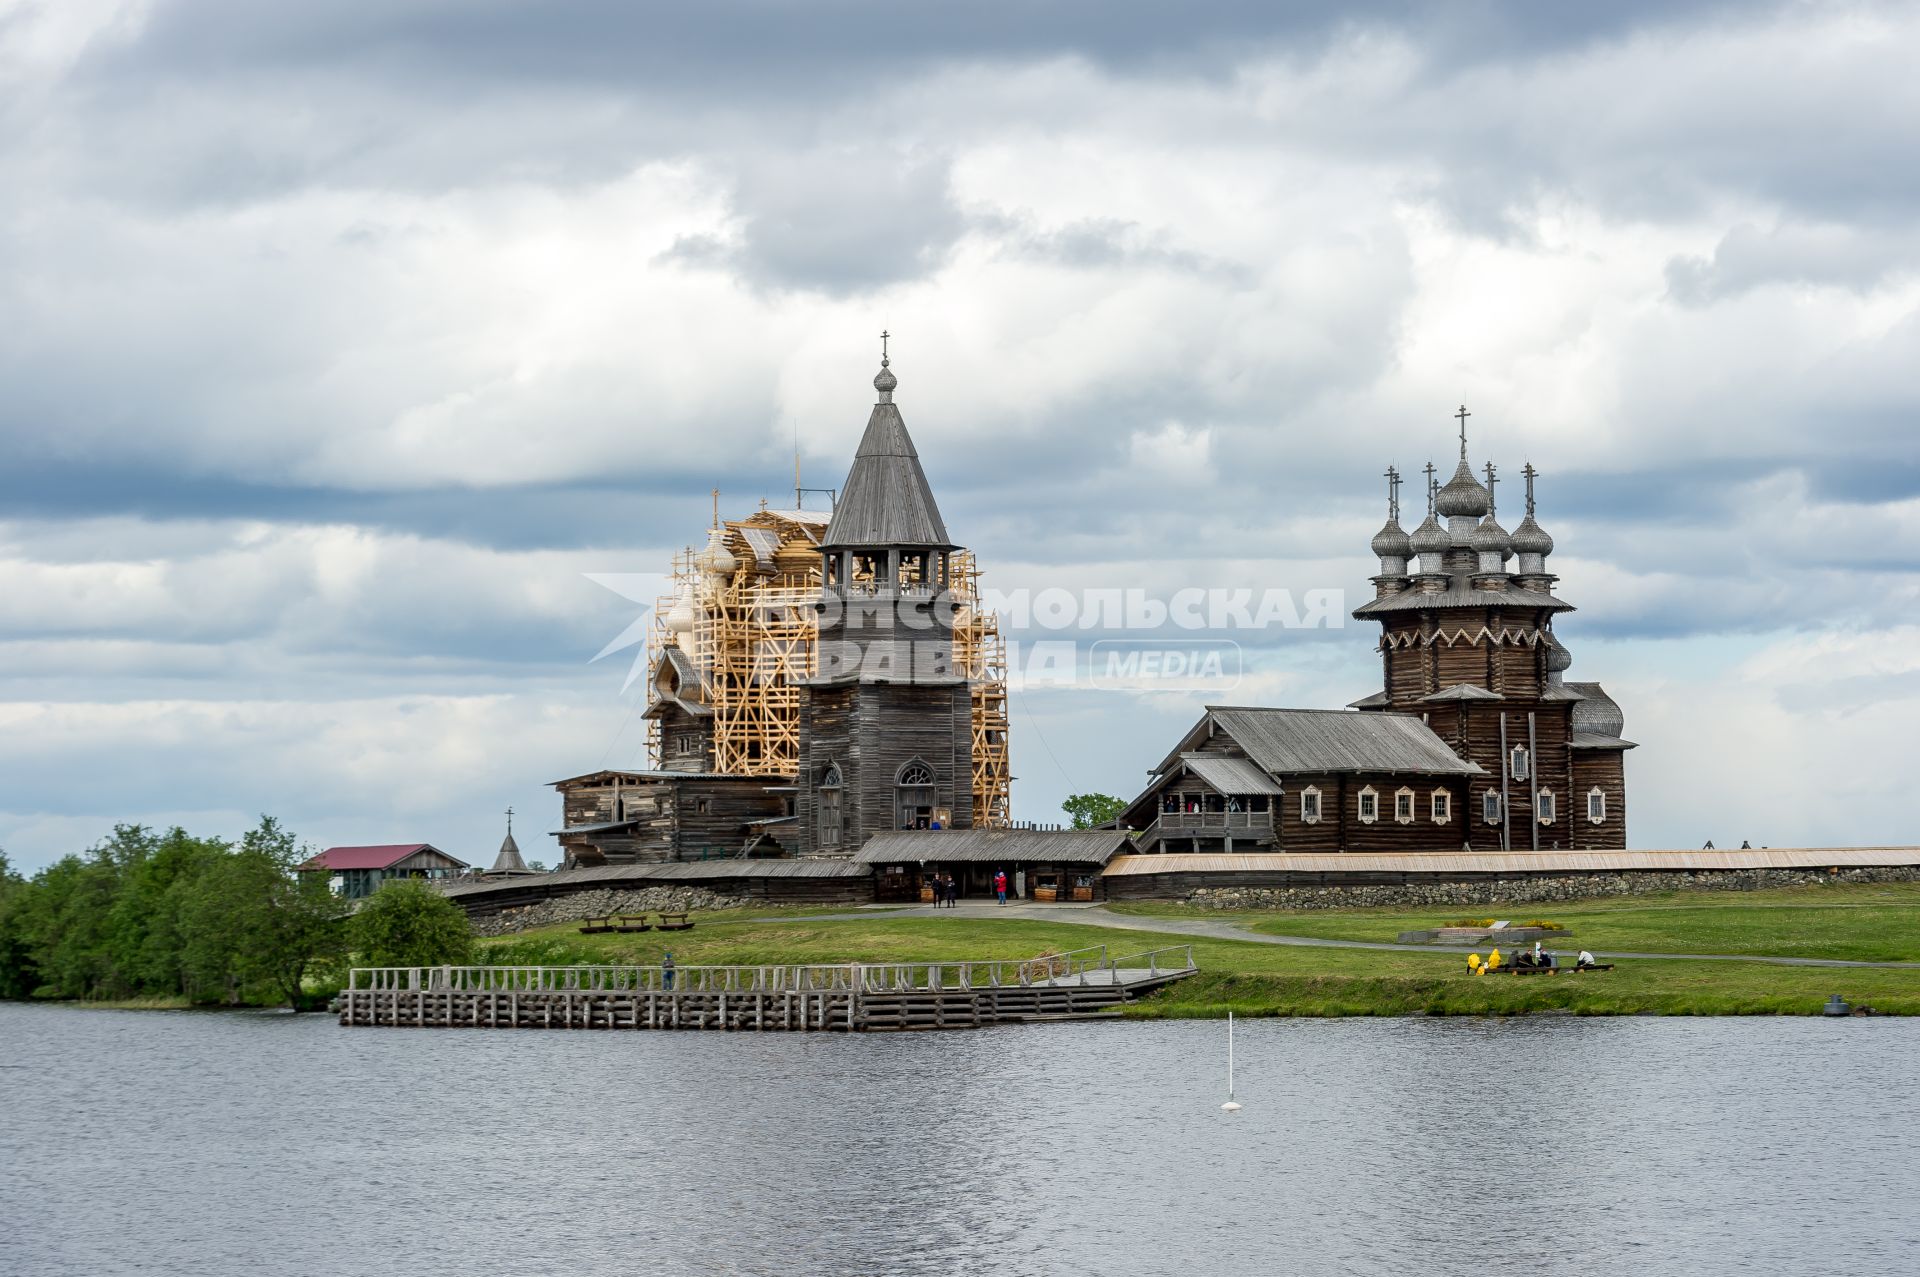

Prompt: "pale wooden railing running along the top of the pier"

[337,945,1196,993]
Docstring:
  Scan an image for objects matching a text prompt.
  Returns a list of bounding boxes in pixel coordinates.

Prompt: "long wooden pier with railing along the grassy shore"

[338,945,1198,1033]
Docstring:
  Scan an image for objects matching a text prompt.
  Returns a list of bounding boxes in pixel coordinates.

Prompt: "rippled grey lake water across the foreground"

[0,1004,1920,1277]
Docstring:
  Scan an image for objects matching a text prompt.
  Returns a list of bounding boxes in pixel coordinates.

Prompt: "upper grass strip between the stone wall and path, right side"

[1112,883,1920,962]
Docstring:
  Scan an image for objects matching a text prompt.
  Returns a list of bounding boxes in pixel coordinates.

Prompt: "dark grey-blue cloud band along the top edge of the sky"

[88,0,1745,96]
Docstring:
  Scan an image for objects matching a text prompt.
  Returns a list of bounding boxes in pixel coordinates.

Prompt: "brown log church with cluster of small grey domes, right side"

[1121,407,1634,853]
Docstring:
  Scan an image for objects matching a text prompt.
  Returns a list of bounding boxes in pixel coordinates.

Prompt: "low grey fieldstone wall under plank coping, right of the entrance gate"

[1183,868,1920,908]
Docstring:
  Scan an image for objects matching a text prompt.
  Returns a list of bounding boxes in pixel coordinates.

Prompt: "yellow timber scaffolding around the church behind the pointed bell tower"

[647,509,1012,828]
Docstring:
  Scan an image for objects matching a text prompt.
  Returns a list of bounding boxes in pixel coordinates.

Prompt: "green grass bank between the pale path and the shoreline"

[482,914,1920,1018]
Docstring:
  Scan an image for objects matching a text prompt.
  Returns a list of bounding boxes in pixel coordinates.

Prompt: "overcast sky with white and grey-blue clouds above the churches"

[0,0,1920,868]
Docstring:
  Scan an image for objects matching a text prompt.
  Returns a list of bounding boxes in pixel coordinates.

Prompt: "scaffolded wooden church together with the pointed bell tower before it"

[553,351,983,868]
